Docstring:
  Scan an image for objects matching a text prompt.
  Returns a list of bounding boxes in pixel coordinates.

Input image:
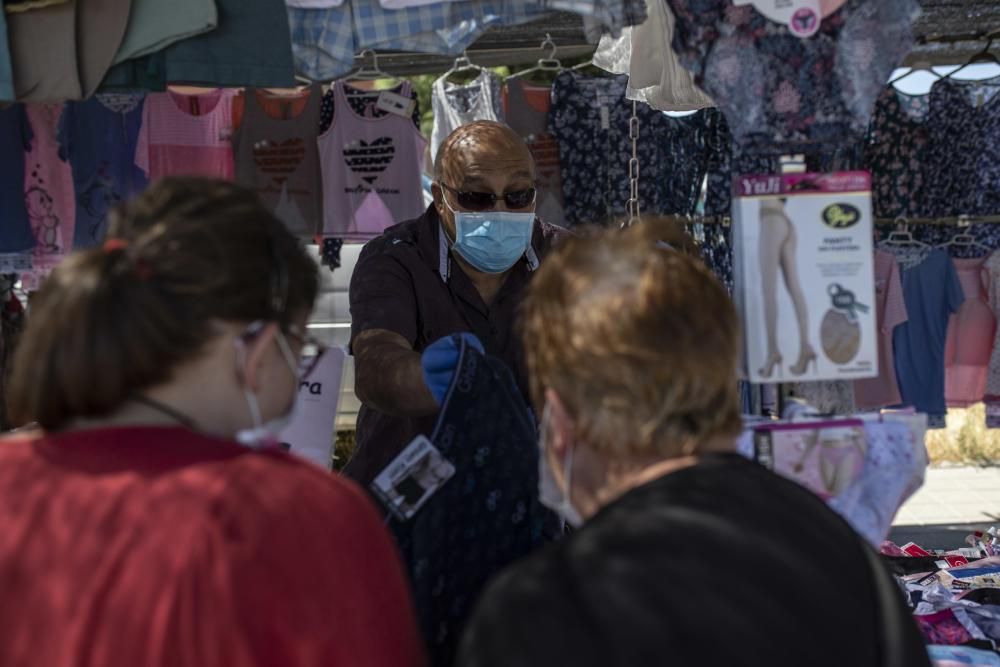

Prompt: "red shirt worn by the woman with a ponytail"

[0,427,424,667]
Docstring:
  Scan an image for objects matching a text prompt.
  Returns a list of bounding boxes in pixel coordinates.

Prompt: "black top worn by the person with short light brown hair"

[457,455,930,667]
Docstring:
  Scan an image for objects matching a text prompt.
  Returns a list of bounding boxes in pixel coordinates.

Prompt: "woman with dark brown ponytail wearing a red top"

[0,179,423,667]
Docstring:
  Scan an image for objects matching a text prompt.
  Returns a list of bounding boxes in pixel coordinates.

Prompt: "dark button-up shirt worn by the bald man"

[344,206,560,487]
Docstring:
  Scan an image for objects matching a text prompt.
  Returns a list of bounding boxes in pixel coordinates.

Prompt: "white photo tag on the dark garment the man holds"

[372,435,455,521]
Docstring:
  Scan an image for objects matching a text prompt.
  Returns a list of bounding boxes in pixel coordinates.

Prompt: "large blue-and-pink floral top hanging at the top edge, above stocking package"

[668,0,919,154]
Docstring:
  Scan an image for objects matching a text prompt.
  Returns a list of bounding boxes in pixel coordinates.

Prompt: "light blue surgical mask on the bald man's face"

[445,199,535,273]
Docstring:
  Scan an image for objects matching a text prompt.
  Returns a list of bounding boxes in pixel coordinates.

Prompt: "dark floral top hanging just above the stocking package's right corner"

[865,86,930,218]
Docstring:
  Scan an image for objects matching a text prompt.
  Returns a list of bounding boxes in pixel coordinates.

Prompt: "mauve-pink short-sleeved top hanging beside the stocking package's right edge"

[854,250,909,410]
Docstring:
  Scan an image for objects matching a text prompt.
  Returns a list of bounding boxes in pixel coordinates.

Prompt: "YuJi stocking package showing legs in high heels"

[733,172,879,383]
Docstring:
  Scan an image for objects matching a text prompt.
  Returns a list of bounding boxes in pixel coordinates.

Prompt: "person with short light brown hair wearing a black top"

[458,223,929,667]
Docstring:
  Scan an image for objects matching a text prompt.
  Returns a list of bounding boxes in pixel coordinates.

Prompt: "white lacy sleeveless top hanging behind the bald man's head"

[431,70,504,158]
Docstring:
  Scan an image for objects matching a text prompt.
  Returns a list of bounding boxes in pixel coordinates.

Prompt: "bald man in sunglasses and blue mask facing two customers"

[345,121,558,488]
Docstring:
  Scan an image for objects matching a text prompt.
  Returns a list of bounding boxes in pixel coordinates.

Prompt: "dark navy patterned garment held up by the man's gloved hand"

[389,341,558,667]
